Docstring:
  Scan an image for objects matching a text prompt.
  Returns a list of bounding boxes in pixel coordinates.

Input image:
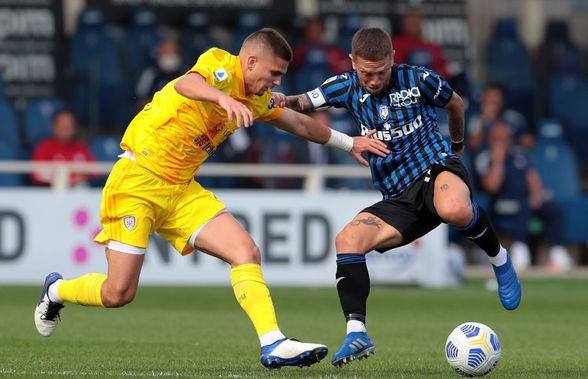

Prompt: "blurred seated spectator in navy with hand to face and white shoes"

[474,120,572,271]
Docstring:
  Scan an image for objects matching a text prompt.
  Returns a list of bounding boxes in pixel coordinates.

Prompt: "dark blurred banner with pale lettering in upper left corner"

[0,0,63,98]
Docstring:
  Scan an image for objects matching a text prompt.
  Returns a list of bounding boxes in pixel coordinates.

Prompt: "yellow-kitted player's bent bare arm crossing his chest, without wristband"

[174,72,253,127]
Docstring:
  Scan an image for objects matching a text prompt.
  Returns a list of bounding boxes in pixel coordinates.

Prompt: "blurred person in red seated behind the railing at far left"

[31,110,94,186]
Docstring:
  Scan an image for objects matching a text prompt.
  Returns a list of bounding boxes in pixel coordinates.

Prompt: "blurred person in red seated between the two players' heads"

[292,16,351,75]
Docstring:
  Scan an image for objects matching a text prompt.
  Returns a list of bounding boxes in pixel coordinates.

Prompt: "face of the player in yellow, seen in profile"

[245,53,288,96]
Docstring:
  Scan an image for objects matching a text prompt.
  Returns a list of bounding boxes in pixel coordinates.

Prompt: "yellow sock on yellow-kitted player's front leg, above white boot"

[231,264,279,337]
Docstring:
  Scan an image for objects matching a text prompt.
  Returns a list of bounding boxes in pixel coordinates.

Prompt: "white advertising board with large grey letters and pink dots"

[0,189,454,287]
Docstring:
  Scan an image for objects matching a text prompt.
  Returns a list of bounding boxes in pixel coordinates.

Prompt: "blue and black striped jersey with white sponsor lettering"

[306,64,455,199]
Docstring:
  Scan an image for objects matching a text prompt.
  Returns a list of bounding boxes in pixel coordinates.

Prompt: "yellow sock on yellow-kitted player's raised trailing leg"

[57,274,106,307]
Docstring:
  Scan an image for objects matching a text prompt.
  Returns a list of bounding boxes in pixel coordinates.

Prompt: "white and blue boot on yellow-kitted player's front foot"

[261,338,329,368]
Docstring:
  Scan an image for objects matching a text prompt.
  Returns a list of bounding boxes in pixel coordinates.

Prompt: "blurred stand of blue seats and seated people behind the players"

[0,8,588,271]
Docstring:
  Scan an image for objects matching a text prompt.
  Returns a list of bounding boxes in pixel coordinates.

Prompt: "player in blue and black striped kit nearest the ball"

[275,28,521,366]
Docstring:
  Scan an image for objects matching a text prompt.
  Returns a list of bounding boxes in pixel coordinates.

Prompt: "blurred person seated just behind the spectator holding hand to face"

[466,84,535,152]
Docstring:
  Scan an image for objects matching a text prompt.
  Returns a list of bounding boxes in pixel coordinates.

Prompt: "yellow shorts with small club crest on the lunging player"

[94,158,225,255]
